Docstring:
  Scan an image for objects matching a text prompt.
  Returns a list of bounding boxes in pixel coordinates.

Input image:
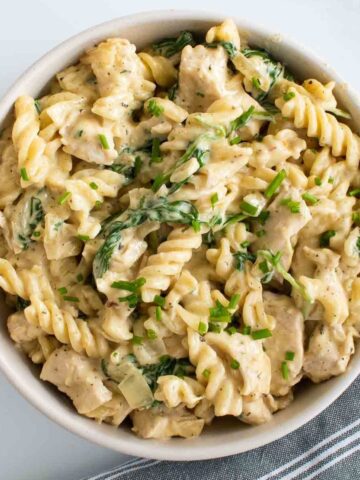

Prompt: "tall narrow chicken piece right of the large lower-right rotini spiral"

[264,292,304,396]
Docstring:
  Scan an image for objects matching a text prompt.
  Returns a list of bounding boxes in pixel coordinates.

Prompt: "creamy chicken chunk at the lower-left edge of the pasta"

[40,347,112,413]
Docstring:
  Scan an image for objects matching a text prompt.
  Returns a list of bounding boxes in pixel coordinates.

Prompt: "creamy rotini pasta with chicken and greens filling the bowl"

[0,12,360,459]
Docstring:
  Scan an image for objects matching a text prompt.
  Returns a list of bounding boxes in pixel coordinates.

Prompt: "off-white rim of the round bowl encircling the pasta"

[0,9,360,461]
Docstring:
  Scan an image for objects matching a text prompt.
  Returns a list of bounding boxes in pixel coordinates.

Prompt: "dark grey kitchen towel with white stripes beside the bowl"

[88,377,360,480]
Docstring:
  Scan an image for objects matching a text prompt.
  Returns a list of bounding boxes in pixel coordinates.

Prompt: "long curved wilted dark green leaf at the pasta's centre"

[93,197,198,278]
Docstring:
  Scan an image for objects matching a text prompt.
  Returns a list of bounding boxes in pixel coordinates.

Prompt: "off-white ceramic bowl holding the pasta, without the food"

[0,10,360,460]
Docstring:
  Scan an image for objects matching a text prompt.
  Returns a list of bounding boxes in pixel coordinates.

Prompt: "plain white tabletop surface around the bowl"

[0,0,360,480]
